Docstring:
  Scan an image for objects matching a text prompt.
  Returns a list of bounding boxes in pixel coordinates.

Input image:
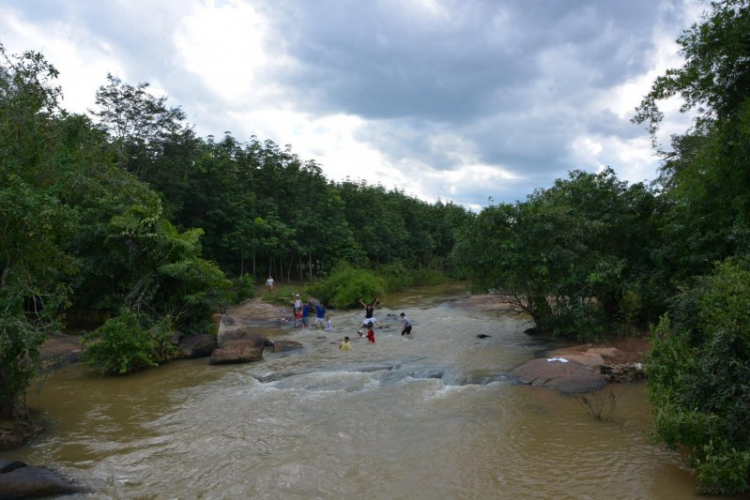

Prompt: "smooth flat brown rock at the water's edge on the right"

[513,358,607,394]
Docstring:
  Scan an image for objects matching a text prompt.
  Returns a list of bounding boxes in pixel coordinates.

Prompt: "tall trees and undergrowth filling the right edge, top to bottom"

[634,0,750,493]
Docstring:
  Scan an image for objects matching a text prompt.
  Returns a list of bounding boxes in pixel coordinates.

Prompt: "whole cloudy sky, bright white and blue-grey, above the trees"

[0,0,705,210]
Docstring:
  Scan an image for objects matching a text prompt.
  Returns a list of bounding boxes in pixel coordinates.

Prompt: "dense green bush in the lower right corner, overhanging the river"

[647,259,750,494]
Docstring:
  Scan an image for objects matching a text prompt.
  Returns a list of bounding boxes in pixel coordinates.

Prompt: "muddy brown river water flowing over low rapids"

[0,286,705,499]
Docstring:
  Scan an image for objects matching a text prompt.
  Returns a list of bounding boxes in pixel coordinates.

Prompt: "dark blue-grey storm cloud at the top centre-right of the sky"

[266,0,684,122]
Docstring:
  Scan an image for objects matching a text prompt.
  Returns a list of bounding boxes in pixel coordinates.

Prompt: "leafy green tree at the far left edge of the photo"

[0,45,75,418]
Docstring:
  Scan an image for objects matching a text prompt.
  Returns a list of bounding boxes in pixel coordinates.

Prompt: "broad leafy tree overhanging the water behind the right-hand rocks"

[454,169,659,340]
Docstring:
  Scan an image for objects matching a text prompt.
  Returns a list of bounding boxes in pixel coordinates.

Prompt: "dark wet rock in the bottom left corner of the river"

[0,466,89,500]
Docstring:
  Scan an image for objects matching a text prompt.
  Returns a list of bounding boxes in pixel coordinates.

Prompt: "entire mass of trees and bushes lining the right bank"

[456,0,750,494]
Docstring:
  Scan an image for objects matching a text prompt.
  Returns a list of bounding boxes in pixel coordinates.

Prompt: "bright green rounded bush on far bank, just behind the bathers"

[308,264,385,309]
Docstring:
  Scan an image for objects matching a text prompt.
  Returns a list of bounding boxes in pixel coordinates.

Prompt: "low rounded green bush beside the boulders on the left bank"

[83,309,174,375]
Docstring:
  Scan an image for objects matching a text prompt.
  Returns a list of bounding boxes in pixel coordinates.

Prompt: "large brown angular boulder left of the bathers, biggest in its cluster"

[210,315,266,365]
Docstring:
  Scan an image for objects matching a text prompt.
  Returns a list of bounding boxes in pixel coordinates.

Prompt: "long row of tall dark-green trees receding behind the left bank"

[93,76,470,281]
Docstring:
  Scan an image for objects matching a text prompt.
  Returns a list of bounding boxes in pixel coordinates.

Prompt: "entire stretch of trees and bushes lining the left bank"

[0,45,472,417]
